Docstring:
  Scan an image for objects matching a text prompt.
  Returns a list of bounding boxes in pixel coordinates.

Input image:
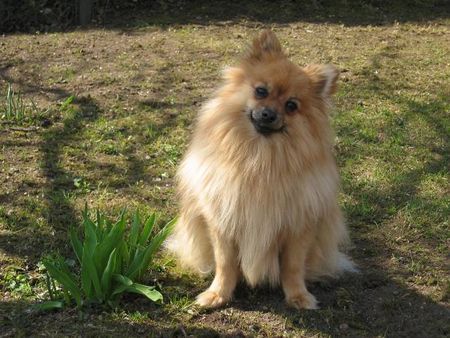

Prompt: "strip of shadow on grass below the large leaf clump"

[0,301,219,337]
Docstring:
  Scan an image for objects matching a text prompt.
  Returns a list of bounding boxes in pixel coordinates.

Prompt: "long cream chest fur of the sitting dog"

[180,139,337,285]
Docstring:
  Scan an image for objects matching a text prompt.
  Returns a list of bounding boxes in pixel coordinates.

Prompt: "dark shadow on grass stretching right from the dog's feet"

[220,268,450,337]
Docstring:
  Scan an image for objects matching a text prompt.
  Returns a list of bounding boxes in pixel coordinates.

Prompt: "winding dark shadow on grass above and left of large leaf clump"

[0,85,99,258]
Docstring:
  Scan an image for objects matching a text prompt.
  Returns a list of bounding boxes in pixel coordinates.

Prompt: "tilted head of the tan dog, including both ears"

[220,30,339,136]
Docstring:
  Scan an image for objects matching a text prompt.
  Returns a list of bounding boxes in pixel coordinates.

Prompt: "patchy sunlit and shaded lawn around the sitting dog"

[0,0,450,337]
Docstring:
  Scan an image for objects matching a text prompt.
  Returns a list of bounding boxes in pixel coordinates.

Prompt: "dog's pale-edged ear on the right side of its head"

[304,65,339,100]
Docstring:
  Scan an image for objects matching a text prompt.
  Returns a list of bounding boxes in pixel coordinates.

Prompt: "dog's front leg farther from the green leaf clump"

[280,229,318,309]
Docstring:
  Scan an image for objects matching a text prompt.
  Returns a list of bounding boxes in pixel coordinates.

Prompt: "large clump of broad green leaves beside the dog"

[41,208,175,309]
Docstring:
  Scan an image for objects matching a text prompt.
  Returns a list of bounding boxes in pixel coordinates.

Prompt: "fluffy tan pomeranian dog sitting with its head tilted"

[168,30,354,309]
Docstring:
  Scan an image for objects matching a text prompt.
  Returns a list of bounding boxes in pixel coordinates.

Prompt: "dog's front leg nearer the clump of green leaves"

[197,231,239,307]
